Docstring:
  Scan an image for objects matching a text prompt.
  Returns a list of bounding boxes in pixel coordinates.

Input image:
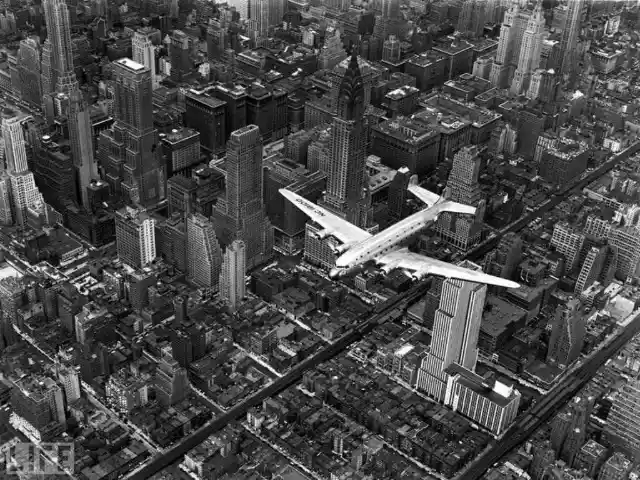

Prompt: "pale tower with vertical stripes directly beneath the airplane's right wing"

[418,260,487,402]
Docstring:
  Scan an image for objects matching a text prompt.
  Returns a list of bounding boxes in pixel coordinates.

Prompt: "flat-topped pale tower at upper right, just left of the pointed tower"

[489,3,529,88]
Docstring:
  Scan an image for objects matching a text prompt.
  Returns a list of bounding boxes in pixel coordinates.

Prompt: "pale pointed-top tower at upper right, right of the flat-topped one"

[511,2,545,95]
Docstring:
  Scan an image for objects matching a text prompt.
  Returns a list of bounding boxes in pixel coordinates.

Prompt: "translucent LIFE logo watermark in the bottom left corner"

[4,442,75,475]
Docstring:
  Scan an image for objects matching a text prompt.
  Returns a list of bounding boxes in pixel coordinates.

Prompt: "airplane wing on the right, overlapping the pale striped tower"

[376,249,520,288]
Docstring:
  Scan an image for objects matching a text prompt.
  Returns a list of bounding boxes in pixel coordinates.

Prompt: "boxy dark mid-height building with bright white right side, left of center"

[116,207,156,268]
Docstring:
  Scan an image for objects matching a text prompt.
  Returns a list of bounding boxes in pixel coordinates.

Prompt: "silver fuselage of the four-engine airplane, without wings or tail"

[331,207,440,277]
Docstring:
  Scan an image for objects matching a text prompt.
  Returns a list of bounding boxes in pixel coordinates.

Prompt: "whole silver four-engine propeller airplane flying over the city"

[280,175,520,288]
